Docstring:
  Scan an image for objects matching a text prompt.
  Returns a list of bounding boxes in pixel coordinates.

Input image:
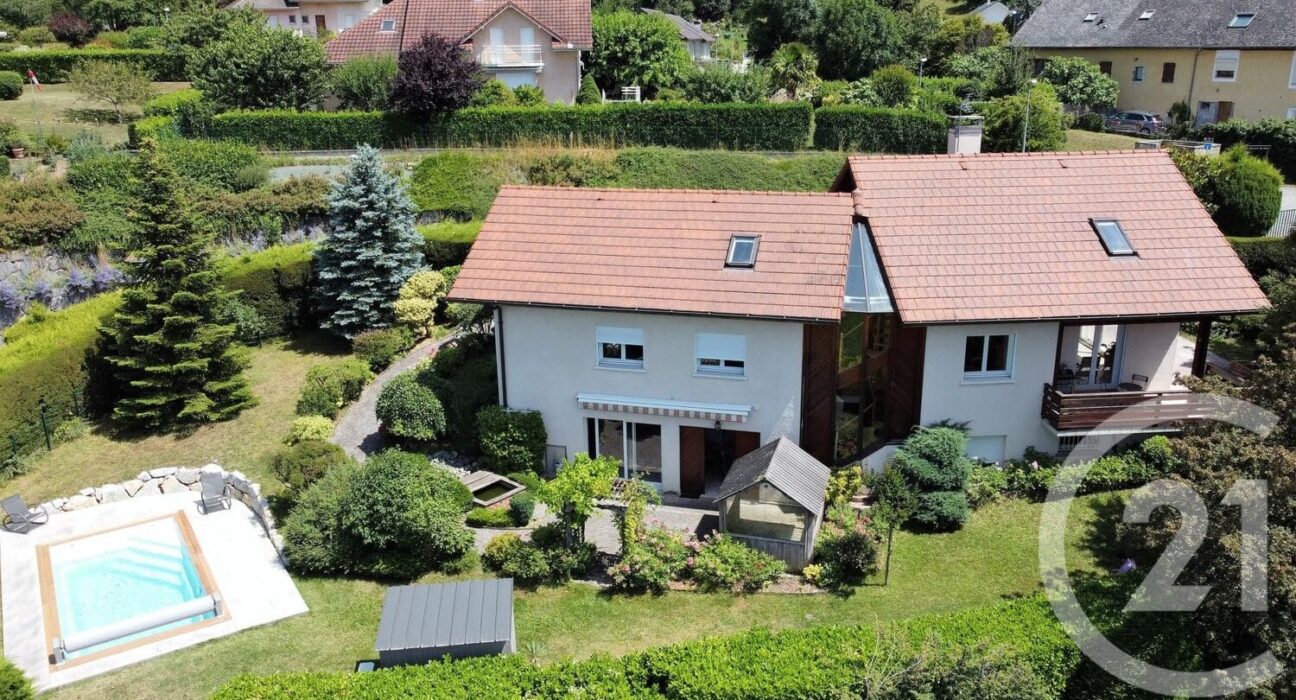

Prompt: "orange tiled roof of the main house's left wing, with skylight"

[450,187,851,321]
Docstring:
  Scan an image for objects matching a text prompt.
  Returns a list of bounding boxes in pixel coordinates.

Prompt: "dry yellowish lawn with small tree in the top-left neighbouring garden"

[0,75,189,144]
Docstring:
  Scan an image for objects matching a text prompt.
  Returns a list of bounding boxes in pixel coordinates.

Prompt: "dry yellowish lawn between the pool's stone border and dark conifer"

[5,336,341,503]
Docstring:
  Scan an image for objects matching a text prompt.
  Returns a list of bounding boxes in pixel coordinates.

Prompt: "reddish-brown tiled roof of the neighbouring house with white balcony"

[324,0,594,64]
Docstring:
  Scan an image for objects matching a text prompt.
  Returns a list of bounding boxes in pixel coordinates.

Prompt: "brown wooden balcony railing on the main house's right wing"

[1041,384,1216,430]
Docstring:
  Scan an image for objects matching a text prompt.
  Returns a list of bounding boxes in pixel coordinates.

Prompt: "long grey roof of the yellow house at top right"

[1012,0,1296,49]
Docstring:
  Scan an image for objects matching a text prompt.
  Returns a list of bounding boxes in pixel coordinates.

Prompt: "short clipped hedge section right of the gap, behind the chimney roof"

[814,105,947,153]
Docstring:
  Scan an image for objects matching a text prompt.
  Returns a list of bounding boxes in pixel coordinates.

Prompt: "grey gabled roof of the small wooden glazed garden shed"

[715,437,832,517]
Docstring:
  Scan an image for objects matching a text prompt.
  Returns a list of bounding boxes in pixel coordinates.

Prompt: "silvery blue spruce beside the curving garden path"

[315,145,422,338]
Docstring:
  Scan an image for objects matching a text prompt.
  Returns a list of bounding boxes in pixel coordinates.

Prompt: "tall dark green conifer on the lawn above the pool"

[100,141,255,430]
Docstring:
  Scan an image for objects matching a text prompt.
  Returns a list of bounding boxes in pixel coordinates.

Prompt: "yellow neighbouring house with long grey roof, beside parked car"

[1013,0,1296,124]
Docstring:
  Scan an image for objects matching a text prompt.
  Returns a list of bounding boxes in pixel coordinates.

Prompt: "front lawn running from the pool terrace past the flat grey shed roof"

[40,496,1103,700]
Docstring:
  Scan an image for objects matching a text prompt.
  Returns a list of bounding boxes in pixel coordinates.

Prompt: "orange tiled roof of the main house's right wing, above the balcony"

[842,150,1267,323]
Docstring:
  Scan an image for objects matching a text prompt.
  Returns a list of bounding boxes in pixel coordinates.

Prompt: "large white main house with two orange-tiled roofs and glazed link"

[451,152,1266,495]
